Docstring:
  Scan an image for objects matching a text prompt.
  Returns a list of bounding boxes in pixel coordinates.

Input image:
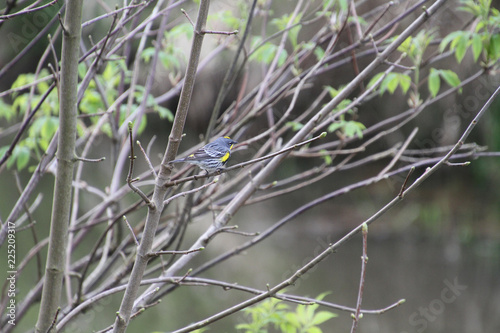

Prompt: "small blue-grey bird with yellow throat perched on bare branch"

[168,136,238,173]
